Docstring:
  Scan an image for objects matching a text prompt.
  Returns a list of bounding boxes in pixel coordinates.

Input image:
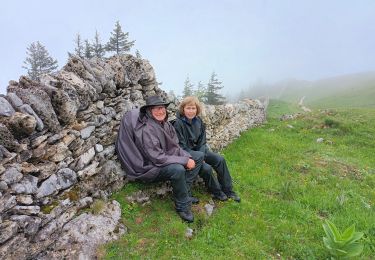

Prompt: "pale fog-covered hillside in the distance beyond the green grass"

[250,72,375,108]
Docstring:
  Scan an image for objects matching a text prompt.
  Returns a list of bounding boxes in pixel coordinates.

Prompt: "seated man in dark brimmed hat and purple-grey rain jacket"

[116,96,203,222]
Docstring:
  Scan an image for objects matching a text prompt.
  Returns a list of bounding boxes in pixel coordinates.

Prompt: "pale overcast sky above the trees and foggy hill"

[0,0,375,94]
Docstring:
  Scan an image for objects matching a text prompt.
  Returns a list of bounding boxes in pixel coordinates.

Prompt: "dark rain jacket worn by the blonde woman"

[173,112,208,154]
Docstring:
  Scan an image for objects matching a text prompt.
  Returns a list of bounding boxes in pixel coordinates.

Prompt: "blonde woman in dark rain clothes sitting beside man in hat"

[173,97,241,202]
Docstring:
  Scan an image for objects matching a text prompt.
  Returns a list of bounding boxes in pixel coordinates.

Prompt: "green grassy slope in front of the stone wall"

[98,101,375,259]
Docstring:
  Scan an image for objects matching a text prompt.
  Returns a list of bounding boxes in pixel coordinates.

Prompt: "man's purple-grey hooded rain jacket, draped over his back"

[116,109,191,182]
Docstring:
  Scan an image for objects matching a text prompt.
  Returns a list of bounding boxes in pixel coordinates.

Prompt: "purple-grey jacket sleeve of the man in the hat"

[142,128,189,167]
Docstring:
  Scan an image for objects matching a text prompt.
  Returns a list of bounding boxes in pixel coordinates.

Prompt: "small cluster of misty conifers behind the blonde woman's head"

[182,72,226,105]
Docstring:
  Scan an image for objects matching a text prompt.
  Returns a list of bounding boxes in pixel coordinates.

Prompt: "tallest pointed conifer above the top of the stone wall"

[107,21,135,55]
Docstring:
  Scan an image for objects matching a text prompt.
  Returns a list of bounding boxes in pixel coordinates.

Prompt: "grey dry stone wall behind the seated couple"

[0,55,265,259]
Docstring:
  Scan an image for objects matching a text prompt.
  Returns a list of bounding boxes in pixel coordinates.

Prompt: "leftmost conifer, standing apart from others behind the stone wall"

[22,41,58,81]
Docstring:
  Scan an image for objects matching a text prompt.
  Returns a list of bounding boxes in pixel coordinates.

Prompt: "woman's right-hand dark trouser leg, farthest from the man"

[204,151,233,192]
